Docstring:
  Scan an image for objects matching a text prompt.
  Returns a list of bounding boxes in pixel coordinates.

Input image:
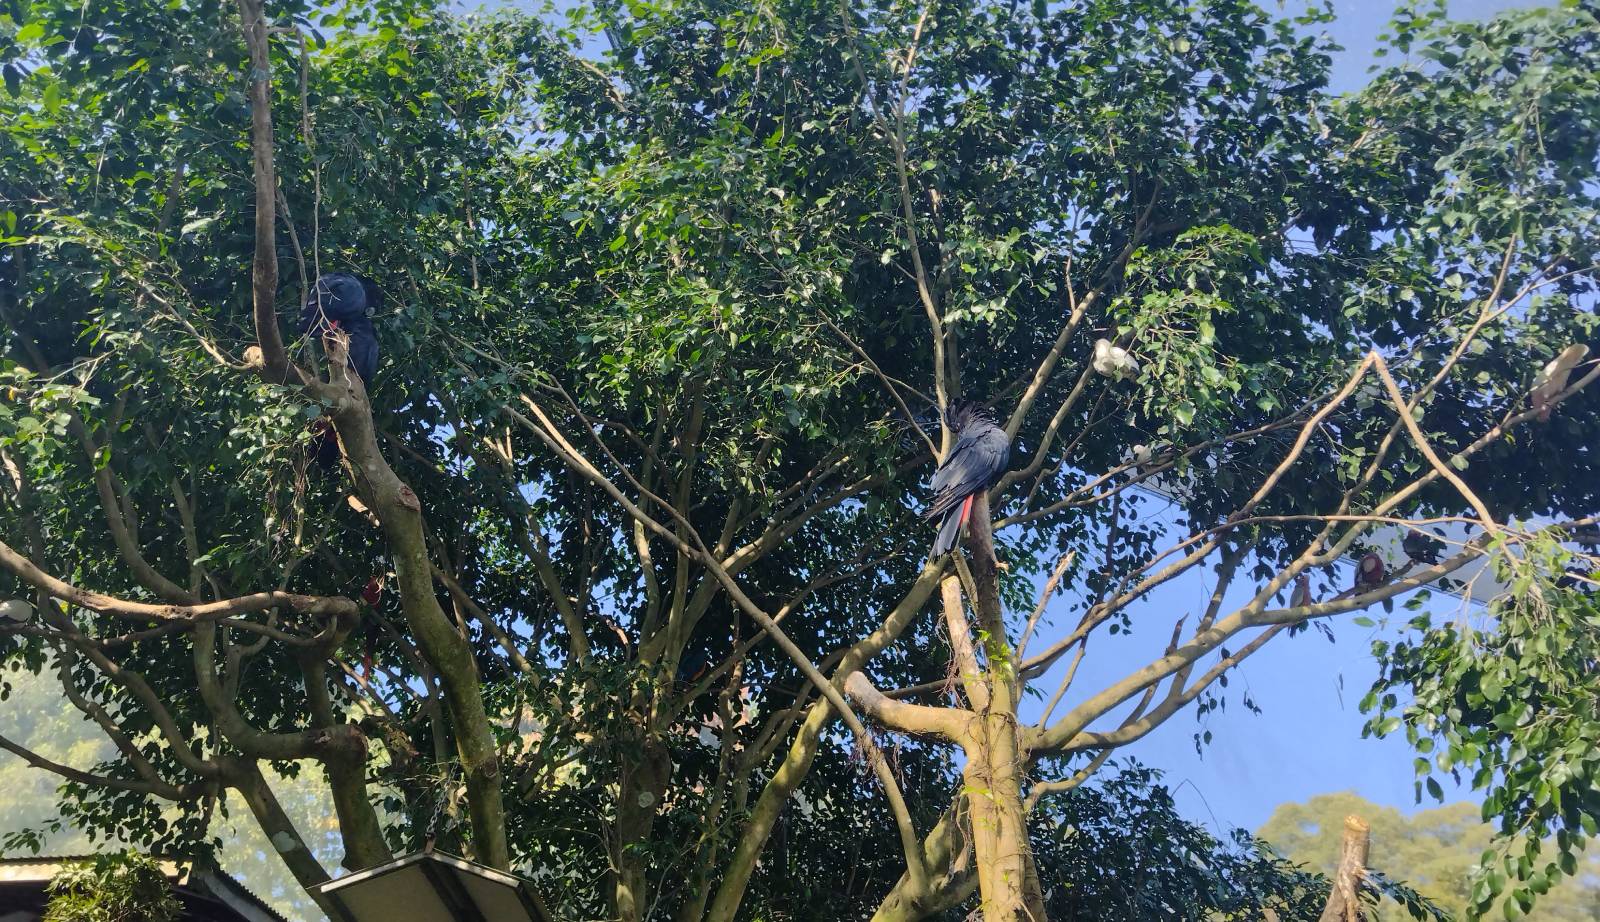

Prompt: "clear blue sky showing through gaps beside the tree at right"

[1032,0,1552,831]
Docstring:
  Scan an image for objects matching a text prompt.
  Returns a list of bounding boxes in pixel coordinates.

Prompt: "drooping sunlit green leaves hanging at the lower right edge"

[1362,543,1600,914]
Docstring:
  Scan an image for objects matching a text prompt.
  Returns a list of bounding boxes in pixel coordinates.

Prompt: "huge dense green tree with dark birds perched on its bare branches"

[0,0,1600,922]
